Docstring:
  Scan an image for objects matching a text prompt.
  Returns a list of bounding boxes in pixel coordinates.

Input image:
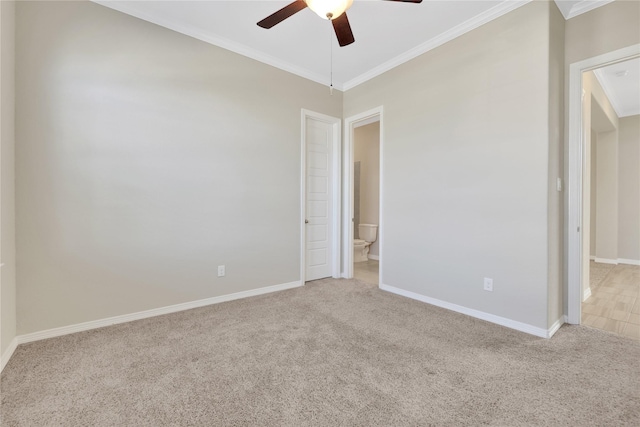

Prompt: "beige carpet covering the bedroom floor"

[1,280,640,427]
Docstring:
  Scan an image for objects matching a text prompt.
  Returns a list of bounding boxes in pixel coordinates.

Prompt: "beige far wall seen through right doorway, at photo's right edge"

[618,116,640,263]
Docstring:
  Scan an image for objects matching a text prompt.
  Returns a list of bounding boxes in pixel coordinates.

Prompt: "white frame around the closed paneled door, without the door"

[300,108,342,285]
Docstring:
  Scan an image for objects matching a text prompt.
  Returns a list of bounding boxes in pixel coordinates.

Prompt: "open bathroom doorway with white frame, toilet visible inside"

[342,107,384,286]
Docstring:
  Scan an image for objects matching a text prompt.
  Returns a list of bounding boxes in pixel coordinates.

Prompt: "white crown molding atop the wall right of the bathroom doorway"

[343,0,532,91]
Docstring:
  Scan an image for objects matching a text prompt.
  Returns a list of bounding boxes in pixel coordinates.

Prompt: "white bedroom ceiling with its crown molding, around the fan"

[94,0,624,90]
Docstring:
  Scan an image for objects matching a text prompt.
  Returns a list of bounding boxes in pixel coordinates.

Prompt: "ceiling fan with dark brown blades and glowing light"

[258,0,422,46]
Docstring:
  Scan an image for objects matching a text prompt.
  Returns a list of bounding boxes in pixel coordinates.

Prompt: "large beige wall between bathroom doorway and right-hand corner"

[344,2,552,329]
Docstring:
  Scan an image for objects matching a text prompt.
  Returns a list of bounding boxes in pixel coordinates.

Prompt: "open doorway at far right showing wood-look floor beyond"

[580,58,640,340]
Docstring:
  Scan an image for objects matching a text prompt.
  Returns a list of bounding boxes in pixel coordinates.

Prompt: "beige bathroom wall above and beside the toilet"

[353,122,380,256]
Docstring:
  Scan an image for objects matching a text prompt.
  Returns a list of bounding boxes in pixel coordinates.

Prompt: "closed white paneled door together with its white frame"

[300,110,341,283]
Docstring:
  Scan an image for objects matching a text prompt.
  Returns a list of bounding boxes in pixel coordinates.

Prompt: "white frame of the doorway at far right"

[565,44,640,325]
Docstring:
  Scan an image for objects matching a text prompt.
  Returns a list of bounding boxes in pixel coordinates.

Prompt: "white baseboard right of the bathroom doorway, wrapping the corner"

[380,285,562,338]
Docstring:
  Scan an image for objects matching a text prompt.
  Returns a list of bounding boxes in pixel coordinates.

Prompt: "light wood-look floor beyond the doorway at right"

[582,261,640,341]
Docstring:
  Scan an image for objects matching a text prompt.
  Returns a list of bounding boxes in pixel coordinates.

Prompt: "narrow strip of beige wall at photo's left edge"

[0,1,16,362]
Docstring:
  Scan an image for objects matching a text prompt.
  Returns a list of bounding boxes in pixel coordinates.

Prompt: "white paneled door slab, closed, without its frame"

[305,117,334,281]
